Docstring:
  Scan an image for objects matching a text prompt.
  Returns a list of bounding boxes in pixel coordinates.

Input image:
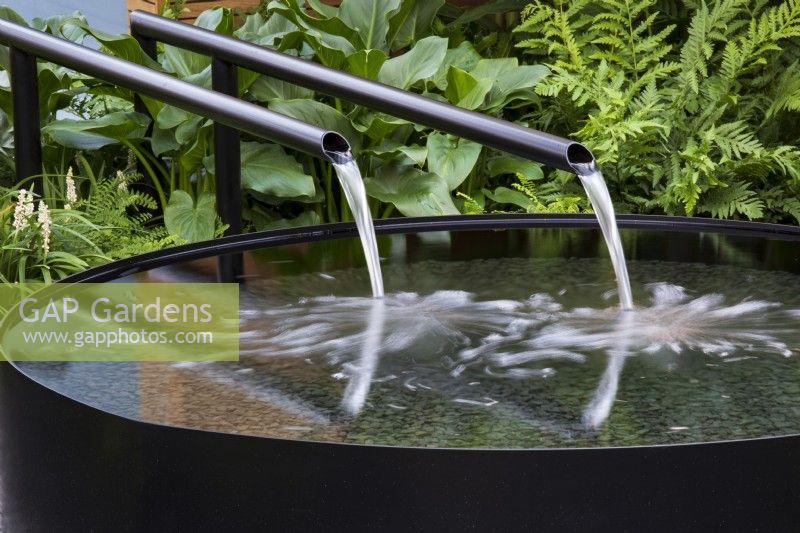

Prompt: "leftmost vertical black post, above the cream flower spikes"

[9,47,43,194]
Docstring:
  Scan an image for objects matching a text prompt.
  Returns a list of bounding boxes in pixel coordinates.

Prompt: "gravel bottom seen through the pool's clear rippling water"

[21,258,800,448]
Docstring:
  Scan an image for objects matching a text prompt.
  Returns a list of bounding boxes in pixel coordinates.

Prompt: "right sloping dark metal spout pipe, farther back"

[130,11,594,172]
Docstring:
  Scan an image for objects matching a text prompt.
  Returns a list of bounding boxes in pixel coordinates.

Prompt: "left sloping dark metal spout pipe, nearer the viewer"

[0,20,347,159]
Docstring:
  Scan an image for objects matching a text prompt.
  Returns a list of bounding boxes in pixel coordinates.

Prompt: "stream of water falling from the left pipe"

[333,152,383,298]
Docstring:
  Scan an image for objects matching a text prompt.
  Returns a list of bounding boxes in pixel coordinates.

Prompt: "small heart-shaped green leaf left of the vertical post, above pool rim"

[164,189,217,242]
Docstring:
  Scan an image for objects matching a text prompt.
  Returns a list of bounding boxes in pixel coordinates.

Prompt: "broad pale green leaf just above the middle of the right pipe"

[378,37,447,89]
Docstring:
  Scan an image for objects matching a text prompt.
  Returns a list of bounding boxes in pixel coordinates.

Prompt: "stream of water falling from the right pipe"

[573,161,633,311]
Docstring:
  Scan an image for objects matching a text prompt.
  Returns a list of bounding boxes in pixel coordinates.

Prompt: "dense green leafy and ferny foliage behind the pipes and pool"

[0,0,800,229]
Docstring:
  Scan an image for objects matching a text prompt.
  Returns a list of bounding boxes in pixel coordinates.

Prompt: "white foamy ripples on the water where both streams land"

[241,262,800,429]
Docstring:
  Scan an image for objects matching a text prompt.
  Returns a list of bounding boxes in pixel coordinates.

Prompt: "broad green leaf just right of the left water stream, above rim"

[364,166,458,217]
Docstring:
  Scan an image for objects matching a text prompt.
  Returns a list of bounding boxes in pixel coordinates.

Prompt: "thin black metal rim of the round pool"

[12,214,780,451]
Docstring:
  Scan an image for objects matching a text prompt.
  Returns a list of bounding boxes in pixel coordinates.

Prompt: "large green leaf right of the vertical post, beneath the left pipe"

[204,142,316,198]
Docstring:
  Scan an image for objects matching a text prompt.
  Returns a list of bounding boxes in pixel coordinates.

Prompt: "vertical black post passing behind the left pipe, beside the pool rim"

[211,57,244,283]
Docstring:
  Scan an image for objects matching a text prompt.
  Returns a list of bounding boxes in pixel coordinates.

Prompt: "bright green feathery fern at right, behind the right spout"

[517,0,800,222]
